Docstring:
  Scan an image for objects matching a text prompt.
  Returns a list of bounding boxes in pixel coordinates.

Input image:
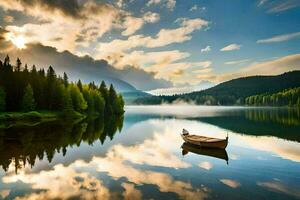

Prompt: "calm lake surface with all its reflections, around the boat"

[0,105,300,200]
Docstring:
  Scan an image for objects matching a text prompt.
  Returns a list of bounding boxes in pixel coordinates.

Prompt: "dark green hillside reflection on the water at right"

[198,108,300,142]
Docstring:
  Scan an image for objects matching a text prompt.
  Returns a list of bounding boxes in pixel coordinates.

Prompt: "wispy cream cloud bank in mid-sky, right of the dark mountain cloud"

[95,18,211,81]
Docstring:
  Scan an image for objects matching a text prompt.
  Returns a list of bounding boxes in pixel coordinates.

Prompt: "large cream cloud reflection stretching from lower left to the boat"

[3,120,208,199]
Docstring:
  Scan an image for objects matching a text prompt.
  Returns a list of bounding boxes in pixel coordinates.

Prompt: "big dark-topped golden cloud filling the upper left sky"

[0,0,158,55]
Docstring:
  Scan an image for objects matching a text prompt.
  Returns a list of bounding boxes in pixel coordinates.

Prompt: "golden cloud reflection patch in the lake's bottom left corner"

[2,164,109,199]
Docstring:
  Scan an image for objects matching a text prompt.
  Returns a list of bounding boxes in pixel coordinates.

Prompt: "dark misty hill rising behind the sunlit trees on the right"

[135,71,300,105]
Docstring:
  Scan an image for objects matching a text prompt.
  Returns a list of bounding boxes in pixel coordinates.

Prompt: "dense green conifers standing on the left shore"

[0,56,124,115]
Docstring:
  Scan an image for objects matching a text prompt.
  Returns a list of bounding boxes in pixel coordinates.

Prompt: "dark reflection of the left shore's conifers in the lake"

[0,117,123,173]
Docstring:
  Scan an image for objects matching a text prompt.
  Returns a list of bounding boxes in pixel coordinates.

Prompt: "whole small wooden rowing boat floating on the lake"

[181,129,228,149]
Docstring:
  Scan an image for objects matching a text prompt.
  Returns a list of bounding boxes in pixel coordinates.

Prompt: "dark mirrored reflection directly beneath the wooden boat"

[181,142,229,164]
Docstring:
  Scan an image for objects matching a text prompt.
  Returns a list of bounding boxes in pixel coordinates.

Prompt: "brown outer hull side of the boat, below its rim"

[181,134,228,149]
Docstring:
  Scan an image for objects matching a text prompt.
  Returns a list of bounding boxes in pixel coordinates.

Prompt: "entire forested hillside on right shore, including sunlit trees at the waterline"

[134,71,300,106]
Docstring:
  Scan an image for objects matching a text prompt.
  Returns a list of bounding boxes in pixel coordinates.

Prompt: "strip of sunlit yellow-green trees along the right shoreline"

[245,87,300,107]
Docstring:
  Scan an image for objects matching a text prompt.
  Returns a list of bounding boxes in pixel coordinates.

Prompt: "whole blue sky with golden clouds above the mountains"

[0,0,300,94]
